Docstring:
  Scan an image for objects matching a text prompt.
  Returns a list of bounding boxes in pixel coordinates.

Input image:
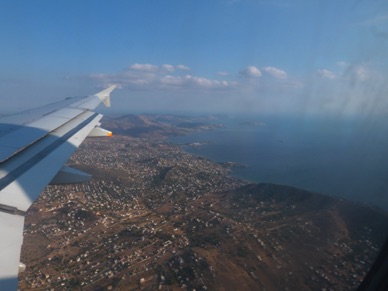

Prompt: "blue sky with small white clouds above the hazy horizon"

[0,0,388,116]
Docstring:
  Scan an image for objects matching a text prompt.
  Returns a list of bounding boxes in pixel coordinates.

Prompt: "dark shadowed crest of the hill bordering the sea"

[232,183,388,243]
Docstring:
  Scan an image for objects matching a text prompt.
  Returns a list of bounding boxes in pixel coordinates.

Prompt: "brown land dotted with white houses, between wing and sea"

[19,136,387,290]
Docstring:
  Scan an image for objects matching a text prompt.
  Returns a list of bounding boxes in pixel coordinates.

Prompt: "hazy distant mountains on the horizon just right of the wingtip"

[102,114,222,138]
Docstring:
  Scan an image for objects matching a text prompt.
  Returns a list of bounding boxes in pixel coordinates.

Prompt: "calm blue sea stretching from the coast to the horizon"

[170,115,388,211]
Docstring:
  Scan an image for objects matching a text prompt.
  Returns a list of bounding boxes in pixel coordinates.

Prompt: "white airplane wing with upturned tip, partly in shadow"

[0,86,115,290]
